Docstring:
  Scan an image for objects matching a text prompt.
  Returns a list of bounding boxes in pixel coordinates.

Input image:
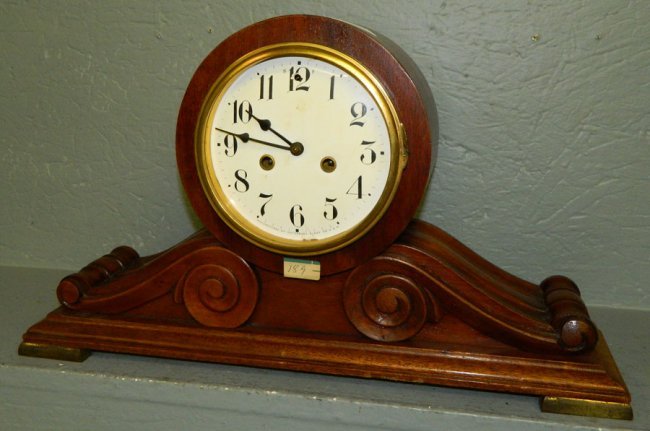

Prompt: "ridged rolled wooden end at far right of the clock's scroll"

[540,275,598,352]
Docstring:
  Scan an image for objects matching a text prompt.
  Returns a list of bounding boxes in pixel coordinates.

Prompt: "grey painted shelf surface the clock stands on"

[0,267,650,431]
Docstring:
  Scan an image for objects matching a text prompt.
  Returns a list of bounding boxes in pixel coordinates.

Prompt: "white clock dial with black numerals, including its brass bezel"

[197,44,405,255]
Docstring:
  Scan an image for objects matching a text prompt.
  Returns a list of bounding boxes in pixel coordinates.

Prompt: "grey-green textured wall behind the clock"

[0,0,650,308]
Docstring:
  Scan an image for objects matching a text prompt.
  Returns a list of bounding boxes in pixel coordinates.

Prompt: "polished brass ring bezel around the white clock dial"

[194,42,408,256]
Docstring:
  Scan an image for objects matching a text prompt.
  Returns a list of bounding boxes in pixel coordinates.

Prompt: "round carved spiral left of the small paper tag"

[181,249,259,328]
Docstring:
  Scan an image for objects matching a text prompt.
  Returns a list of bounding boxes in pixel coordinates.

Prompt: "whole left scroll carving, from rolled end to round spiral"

[57,231,259,328]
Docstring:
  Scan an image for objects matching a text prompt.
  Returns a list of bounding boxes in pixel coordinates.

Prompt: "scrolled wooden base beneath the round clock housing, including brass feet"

[19,220,632,419]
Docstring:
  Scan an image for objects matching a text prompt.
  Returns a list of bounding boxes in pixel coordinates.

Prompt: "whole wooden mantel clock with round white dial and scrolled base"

[19,15,632,418]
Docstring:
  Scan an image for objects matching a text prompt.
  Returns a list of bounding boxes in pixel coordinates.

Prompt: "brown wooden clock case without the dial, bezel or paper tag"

[19,15,632,419]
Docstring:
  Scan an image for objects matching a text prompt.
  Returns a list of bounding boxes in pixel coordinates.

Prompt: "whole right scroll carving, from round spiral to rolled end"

[344,221,598,352]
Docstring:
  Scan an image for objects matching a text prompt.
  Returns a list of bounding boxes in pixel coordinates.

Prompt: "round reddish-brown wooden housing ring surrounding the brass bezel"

[176,15,438,275]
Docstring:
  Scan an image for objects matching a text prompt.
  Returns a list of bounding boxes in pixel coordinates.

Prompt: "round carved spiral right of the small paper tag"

[343,259,437,341]
